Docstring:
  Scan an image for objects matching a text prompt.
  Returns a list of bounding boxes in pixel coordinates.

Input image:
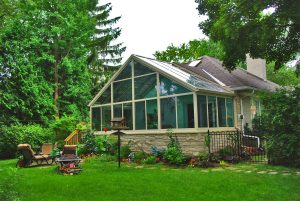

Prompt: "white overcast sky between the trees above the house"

[99,0,205,62]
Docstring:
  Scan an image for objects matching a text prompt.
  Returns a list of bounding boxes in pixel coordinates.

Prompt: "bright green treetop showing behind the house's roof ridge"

[154,39,224,63]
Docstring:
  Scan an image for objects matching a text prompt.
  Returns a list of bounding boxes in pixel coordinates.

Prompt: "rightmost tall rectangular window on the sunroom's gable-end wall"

[177,95,194,128]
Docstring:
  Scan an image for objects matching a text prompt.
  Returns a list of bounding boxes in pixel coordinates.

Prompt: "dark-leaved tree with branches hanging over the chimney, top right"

[196,0,300,70]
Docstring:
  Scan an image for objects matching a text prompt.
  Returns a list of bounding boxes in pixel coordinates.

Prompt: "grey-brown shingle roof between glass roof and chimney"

[179,56,279,91]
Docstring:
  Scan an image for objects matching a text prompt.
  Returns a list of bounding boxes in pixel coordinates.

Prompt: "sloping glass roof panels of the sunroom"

[135,55,228,92]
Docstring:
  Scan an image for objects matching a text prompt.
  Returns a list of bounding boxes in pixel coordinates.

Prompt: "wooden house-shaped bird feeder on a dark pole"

[110,118,129,167]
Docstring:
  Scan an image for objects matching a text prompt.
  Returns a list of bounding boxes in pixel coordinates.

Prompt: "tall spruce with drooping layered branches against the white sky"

[88,3,126,95]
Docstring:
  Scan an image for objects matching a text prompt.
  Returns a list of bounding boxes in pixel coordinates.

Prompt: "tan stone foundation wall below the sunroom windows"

[121,133,207,155]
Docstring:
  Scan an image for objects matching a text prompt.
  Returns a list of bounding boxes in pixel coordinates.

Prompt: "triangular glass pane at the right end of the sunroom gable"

[159,75,190,96]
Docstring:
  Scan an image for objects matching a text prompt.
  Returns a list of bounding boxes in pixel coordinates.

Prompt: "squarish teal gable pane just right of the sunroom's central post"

[134,74,157,99]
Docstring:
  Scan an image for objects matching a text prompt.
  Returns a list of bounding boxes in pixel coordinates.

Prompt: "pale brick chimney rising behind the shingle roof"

[246,54,267,80]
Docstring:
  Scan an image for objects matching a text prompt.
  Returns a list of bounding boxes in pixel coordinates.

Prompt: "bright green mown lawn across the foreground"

[0,159,300,201]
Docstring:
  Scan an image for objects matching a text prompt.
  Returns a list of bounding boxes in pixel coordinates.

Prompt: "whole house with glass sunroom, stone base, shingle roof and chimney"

[89,55,279,154]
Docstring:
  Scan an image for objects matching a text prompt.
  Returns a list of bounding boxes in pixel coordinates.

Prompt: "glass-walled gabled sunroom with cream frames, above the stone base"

[89,55,235,134]
